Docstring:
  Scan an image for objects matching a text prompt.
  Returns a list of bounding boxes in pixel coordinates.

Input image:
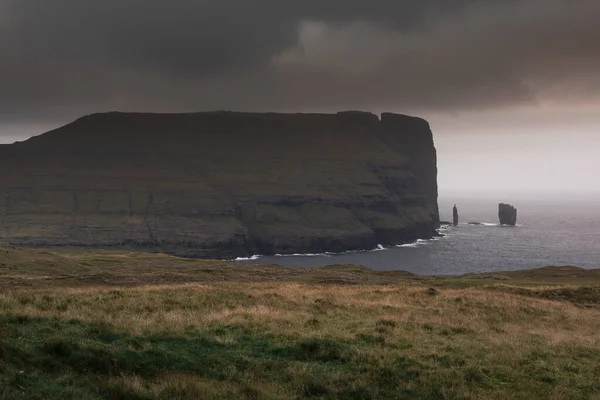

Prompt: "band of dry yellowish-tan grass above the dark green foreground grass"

[0,283,600,343]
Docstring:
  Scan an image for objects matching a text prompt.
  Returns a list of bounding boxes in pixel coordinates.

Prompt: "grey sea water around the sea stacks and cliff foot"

[240,196,600,275]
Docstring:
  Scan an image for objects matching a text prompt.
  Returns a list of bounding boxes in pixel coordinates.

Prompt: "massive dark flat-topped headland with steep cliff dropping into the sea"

[0,112,439,257]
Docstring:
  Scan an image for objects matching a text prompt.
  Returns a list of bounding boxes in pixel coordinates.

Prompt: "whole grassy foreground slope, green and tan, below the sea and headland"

[0,244,600,399]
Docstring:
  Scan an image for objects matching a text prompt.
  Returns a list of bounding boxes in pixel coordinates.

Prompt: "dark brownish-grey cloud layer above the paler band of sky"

[0,0,600,121]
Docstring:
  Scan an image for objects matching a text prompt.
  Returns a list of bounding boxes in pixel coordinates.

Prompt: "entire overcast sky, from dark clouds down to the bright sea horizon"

[0,0,600,196]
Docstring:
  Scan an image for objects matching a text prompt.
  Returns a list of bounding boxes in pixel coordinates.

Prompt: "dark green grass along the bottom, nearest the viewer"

[0,315,600,399]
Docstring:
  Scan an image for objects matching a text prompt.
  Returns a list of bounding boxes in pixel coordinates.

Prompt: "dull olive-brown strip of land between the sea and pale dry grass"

[0,245,600,282]
